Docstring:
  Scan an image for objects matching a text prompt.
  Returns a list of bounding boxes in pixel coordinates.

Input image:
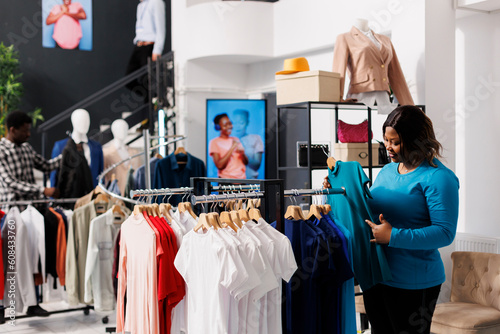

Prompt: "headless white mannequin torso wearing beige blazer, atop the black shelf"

[332,18,414,114]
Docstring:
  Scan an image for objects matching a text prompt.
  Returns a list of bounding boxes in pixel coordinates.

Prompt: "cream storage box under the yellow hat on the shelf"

[276,71,340,105]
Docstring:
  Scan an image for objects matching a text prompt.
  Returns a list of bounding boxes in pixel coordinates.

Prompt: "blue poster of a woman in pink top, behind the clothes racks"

[206,99,266,179]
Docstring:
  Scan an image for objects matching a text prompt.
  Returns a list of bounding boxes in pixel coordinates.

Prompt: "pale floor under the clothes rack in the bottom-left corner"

[0,302,116,334]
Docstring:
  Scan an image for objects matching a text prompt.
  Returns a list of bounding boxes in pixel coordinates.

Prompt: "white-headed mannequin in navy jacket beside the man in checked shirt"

[50,109,104,189]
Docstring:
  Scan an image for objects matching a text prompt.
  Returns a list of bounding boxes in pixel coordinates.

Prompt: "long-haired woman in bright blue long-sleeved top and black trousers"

[363,106,459,334]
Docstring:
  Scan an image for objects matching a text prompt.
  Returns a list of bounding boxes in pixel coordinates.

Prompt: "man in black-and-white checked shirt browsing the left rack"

[0,111,61,202]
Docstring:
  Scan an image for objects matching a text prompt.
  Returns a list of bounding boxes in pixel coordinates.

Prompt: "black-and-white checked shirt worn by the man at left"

[0,138,61,205]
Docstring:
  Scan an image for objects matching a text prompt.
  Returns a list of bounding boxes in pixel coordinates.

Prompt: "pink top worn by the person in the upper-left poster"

[51,2,82,49]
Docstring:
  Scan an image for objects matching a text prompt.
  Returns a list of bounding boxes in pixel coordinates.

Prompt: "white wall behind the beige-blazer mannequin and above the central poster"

[172,0,425,158]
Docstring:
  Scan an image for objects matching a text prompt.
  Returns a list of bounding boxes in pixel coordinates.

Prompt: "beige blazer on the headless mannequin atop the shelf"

[333,27,414,105]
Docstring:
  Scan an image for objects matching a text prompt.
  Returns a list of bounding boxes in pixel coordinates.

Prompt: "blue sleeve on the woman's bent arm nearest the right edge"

[389,169,459,249]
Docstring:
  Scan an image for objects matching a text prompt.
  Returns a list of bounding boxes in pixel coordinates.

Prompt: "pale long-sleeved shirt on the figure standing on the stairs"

[134,0,166,54]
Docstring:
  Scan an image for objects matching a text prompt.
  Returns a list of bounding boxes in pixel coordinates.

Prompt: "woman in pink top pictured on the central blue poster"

[209,113,248,179]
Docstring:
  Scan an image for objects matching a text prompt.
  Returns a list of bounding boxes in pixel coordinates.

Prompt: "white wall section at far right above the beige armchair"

[456,14,500,237]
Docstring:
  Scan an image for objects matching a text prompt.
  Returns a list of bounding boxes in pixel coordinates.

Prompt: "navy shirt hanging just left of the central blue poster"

[153,153,207,206]
